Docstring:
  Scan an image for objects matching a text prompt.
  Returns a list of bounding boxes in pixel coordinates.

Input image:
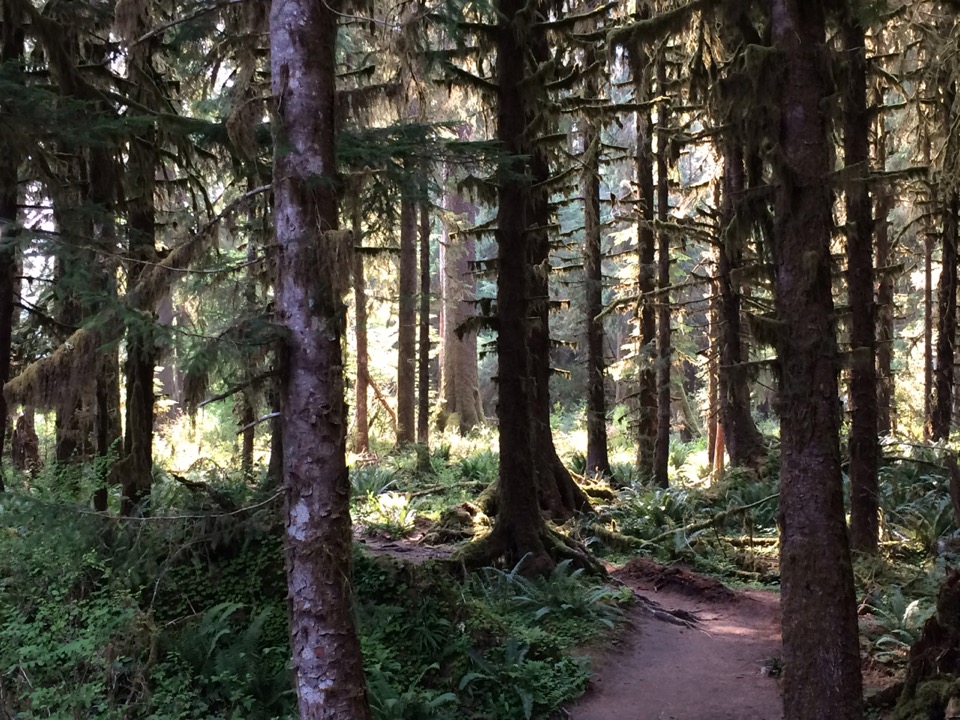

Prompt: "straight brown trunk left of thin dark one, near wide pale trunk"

[397,192,417,445]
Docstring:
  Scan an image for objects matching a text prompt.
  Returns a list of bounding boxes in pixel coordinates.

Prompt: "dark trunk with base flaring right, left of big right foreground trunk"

[716,137,766,469]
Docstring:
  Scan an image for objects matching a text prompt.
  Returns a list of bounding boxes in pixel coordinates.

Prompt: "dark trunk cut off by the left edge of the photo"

[0,2,24,480]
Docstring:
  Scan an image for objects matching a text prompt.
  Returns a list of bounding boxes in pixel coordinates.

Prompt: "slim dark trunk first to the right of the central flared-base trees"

[580,94,610,475]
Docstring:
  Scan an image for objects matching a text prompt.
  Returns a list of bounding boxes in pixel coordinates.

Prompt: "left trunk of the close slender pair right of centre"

[631,52,657,479]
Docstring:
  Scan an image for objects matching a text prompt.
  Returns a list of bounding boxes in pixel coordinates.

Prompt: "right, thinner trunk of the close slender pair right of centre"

[653,59,673,487]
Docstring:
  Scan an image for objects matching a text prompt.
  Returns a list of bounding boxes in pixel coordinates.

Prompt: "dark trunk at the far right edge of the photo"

[930,193,958,442]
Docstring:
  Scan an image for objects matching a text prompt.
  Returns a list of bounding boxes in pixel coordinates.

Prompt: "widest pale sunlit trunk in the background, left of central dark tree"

[439,188,484,434]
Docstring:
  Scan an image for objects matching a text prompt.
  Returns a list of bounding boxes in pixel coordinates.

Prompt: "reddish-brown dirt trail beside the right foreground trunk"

[569,560,783,720]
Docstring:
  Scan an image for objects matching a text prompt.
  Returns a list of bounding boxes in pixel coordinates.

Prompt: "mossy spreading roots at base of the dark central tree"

[451,526,607,577]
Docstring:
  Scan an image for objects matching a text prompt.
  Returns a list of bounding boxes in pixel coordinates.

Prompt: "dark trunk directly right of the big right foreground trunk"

[842,13,880,555]
